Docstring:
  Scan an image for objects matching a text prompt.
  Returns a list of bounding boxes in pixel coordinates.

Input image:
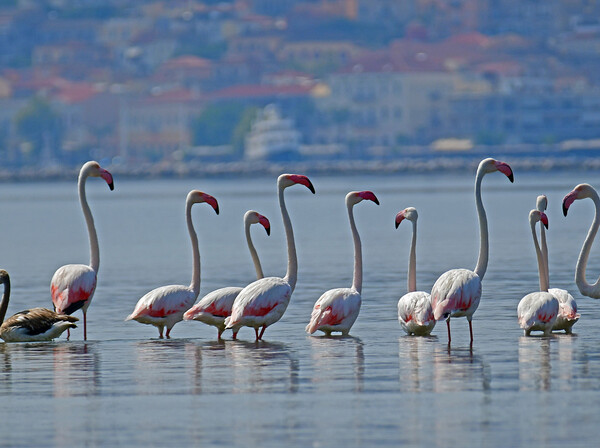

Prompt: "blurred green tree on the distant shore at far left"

[15,96,62,162]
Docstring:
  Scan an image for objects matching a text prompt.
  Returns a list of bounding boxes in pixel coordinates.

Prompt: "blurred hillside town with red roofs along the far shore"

[0,0,600,173]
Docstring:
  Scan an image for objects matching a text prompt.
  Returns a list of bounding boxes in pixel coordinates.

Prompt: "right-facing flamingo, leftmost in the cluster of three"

[125,190,219,339]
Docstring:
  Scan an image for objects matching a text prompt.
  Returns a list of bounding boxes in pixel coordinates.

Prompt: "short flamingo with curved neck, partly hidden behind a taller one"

[183,210,271,340]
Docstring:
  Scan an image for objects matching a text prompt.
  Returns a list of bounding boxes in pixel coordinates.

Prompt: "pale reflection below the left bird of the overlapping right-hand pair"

[519,336,554,390]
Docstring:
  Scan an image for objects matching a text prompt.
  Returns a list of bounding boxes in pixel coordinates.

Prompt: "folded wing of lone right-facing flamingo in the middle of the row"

[306,288,361,334]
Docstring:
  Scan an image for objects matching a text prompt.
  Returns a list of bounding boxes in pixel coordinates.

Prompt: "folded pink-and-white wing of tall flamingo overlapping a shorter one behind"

[226,277,292,328]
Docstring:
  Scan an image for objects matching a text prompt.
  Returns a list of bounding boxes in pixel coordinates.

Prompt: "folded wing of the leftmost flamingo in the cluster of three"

[125,285,196,320]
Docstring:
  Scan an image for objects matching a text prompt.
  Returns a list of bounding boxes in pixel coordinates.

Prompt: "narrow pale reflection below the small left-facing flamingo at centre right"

[398,336,437,392]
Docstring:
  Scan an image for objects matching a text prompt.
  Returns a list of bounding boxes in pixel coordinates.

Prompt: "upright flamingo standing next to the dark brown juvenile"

[50,161,115,341]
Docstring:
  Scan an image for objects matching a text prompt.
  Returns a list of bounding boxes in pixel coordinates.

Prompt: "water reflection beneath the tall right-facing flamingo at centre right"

[433,344,492,392]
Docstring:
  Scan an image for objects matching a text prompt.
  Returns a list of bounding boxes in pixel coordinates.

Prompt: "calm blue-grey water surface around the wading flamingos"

[0,172,600,447]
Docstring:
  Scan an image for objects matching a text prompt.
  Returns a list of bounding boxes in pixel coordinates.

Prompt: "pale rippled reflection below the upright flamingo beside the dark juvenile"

[52,342,100,397]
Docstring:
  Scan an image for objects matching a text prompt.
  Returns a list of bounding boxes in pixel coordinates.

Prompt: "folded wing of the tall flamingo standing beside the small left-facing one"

[431,269,481,320]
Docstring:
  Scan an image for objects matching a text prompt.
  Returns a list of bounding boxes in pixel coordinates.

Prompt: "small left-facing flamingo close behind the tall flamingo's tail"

[396,207,436,336]
